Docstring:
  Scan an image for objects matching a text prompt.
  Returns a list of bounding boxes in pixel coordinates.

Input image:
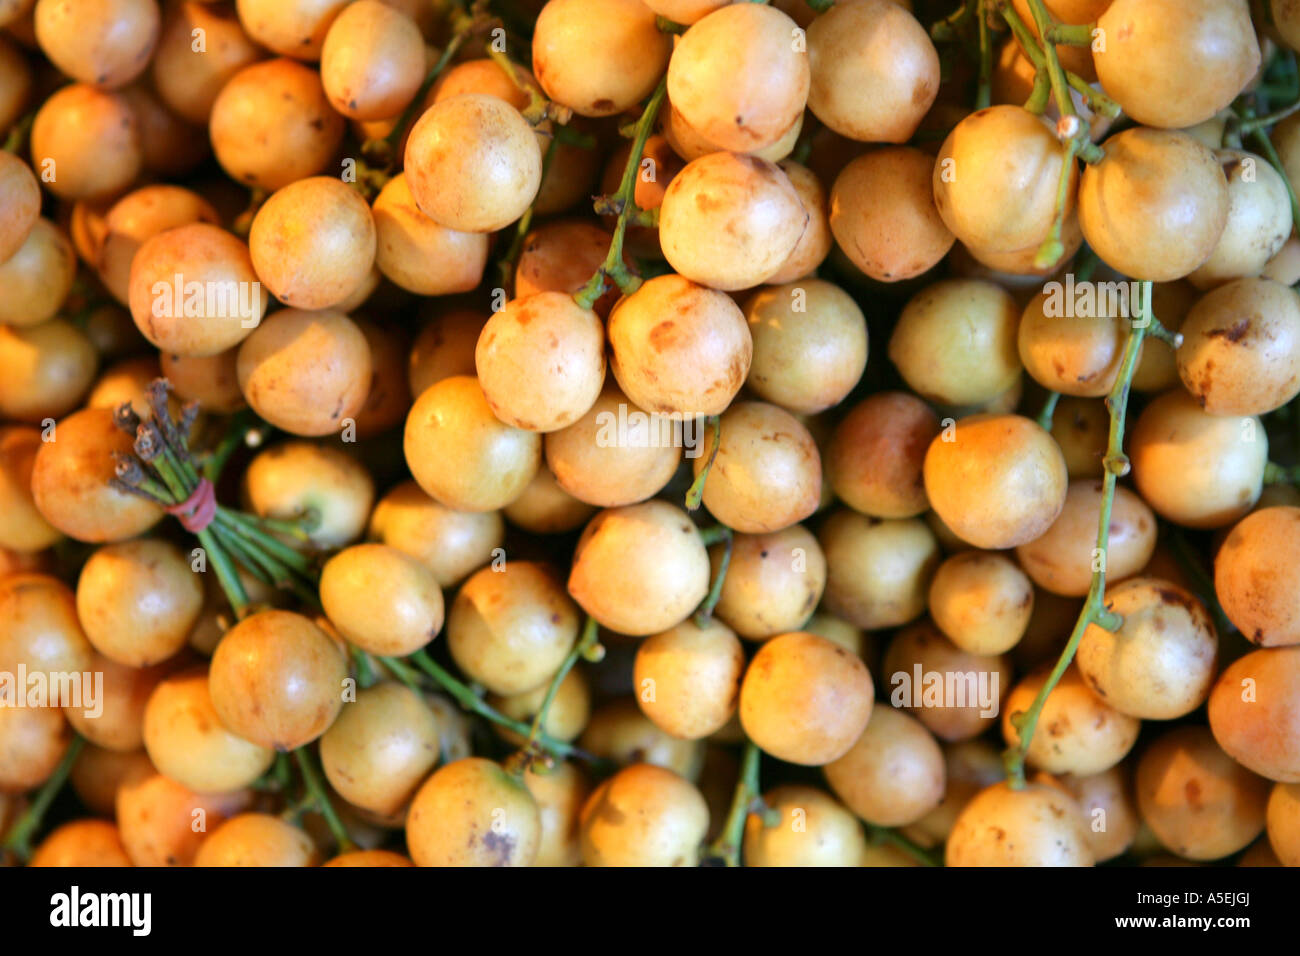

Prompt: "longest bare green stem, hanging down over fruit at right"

[1004,282,1151,788]
